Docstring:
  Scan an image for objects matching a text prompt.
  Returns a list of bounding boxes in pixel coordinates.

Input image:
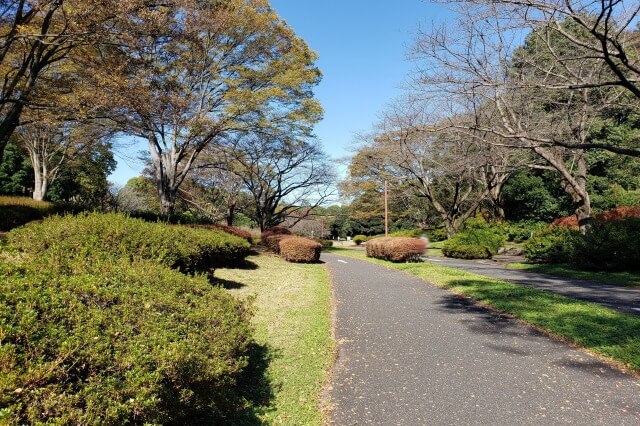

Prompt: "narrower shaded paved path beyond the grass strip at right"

[427,257,640,315]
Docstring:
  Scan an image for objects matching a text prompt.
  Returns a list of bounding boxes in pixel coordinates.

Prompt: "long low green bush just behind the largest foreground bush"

[7,213,250,273]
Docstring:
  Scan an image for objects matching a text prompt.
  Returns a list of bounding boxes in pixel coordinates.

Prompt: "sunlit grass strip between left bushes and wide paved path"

[215,255,333,425]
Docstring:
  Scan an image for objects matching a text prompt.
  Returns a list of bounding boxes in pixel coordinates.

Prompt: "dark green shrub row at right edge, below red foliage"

[524,217,640,271]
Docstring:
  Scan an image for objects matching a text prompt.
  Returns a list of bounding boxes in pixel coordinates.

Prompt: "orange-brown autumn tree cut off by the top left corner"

[0,0,155,161]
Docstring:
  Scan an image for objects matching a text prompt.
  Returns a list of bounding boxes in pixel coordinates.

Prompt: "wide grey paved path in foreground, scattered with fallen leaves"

[323,254,640,425]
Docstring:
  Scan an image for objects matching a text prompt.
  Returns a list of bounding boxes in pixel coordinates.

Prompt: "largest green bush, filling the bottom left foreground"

[0,256,251,424]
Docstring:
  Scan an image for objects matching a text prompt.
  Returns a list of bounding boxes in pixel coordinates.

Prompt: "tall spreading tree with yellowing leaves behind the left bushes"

[91,0,322,213]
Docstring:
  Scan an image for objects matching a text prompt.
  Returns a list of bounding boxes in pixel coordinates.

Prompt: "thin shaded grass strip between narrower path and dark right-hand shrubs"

[507,263,640,287]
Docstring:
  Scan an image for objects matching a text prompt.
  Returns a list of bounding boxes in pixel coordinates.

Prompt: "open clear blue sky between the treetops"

[110,0,451,185]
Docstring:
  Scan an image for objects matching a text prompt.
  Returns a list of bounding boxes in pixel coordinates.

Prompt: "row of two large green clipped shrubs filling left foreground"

[0,214,251,424]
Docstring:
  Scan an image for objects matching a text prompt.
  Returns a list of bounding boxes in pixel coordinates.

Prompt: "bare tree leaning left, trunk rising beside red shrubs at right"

[415,5,622,231]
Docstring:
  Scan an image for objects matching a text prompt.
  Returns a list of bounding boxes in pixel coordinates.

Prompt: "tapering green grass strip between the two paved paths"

[333,249,640,373]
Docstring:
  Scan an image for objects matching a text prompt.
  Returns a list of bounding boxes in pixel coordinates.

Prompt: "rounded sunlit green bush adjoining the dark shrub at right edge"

[524,226,581,263]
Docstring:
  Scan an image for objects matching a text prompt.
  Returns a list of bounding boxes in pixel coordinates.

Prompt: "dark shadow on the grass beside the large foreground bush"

[224,343,277,425]
